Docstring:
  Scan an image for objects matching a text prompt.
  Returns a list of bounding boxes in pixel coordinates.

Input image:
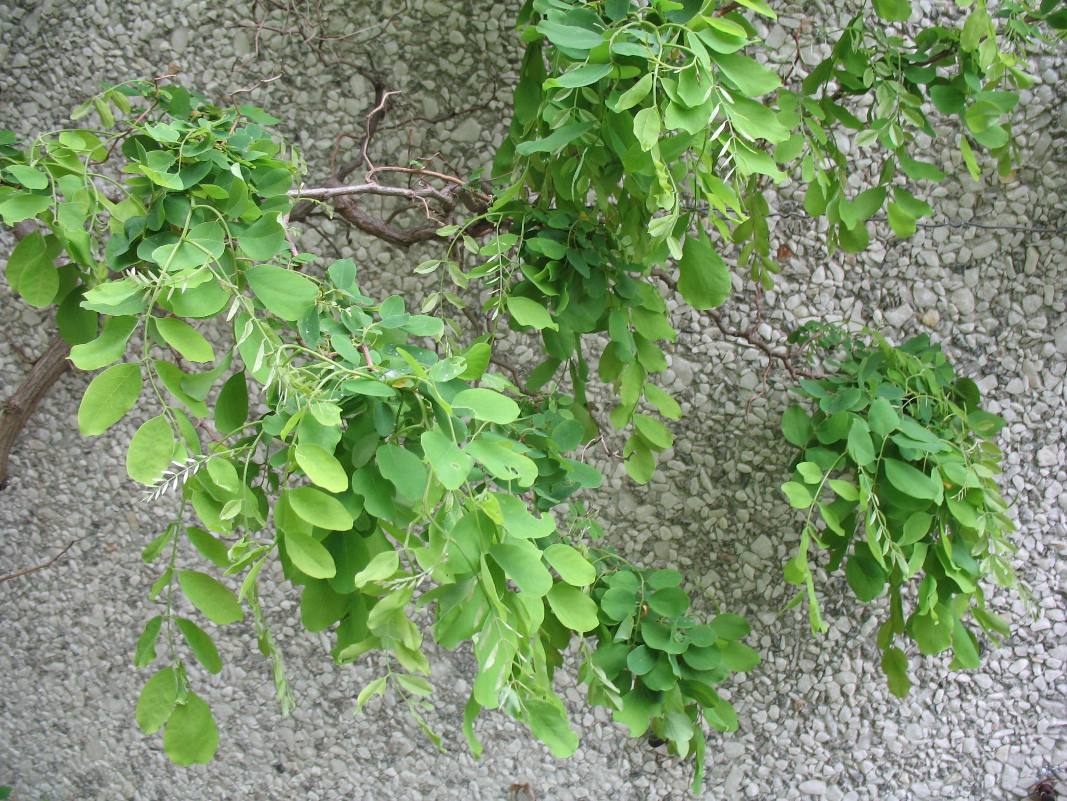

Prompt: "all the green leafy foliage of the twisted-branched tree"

[0,0,1065,785]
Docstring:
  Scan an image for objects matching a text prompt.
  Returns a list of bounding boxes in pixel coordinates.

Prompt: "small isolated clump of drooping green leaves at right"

[782,335,1016,695]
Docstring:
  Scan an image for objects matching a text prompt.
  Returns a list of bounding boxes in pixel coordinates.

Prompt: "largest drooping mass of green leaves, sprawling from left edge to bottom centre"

[0,78,754,780]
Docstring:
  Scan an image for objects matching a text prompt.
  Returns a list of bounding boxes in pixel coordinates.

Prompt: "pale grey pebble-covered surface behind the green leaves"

[0,0,1067,801]
